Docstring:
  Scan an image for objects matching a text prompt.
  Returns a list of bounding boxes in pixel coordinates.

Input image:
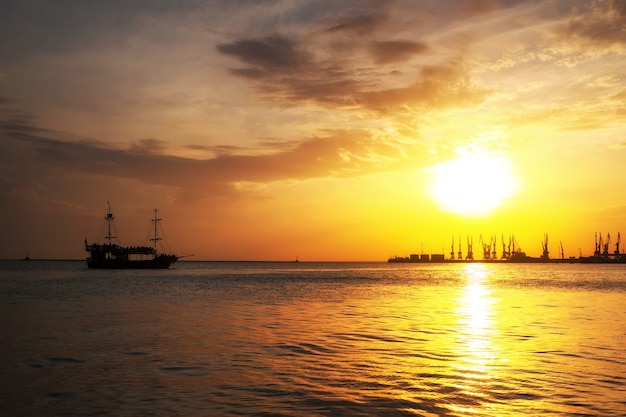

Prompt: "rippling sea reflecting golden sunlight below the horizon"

[0,260,626,417]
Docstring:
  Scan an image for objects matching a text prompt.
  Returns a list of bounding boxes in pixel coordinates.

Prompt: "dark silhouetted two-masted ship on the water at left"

[85,205,180,269]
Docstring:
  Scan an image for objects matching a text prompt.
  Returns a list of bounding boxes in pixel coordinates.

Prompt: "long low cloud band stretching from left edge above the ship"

[0,107,422,203]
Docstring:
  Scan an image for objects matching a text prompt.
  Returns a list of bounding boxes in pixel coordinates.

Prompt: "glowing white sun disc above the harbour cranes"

[431,152,517,217]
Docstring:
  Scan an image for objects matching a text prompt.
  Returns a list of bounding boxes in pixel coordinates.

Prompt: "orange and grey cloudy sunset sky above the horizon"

[0,0,626,261]
